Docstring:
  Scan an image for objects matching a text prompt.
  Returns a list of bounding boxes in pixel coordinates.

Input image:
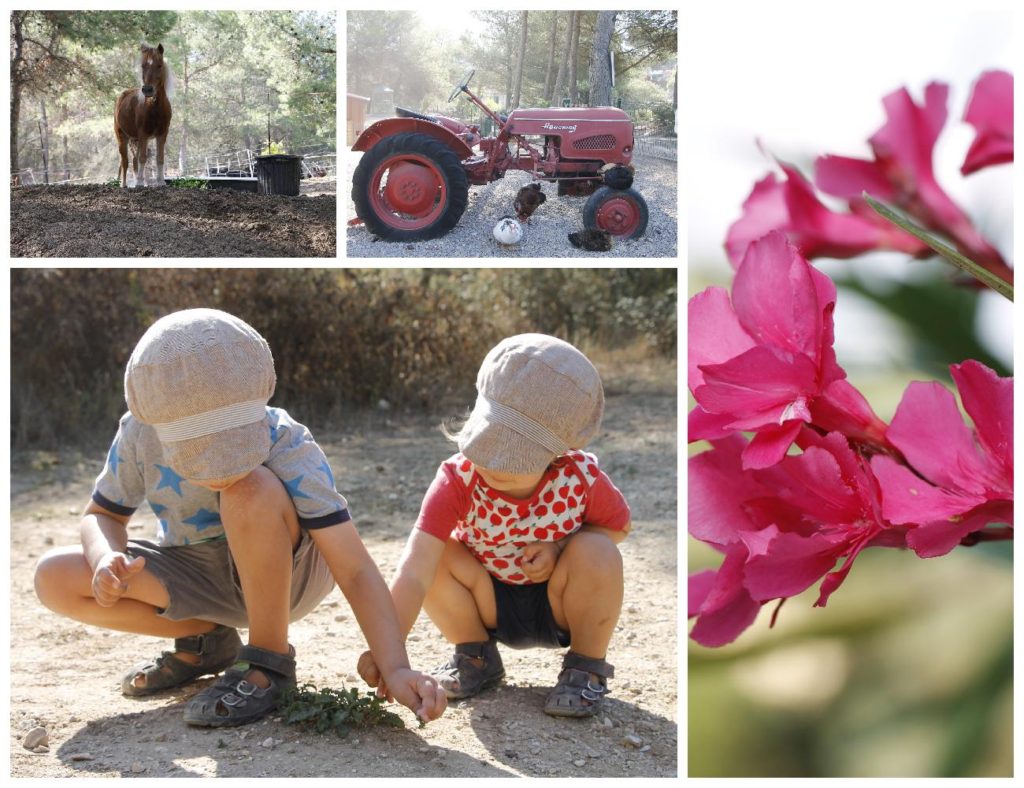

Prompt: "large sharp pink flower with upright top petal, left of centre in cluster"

[687,232,887,468]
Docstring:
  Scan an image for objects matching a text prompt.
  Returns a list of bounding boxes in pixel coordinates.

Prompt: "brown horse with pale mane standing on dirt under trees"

[114,44,171,187]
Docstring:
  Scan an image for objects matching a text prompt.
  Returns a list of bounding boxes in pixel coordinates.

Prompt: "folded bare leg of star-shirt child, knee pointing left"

[35,546,216,646]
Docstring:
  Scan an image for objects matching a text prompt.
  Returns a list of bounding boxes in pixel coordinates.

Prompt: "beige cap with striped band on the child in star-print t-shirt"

[125,309,276,481]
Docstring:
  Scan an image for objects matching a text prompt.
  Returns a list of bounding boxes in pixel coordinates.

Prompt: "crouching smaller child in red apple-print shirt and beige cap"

[359,334,630,716]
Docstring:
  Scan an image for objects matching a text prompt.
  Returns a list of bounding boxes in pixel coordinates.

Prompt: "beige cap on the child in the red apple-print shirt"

[456,334,604,474]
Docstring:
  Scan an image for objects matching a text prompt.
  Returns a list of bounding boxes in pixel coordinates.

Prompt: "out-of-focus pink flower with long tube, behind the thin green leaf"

[814,82,1013,281]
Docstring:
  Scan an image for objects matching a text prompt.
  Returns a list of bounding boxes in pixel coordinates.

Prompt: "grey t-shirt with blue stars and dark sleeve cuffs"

[92,407,351,546]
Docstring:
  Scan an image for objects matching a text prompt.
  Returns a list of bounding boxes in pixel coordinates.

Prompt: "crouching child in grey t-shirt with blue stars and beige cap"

[36,309,446,727]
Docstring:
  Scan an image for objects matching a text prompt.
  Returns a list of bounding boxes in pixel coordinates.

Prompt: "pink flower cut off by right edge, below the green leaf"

[871,360,1014,558]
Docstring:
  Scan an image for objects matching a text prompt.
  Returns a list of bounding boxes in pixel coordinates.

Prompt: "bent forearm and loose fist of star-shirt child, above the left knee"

[80,500,145,607]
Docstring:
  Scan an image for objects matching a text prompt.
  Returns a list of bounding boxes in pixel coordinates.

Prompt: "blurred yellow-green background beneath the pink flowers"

[688,540,1013,777]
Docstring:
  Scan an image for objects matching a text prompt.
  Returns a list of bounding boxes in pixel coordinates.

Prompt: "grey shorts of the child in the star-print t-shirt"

[127,530,334,627]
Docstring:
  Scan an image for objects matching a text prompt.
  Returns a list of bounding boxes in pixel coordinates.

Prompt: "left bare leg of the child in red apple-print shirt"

[423,539,498,644]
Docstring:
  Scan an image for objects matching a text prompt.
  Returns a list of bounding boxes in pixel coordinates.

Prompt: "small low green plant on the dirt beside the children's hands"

[282,684,406,738]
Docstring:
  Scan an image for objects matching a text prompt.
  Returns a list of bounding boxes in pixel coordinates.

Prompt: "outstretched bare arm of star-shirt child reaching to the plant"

[309,522,447,720]
